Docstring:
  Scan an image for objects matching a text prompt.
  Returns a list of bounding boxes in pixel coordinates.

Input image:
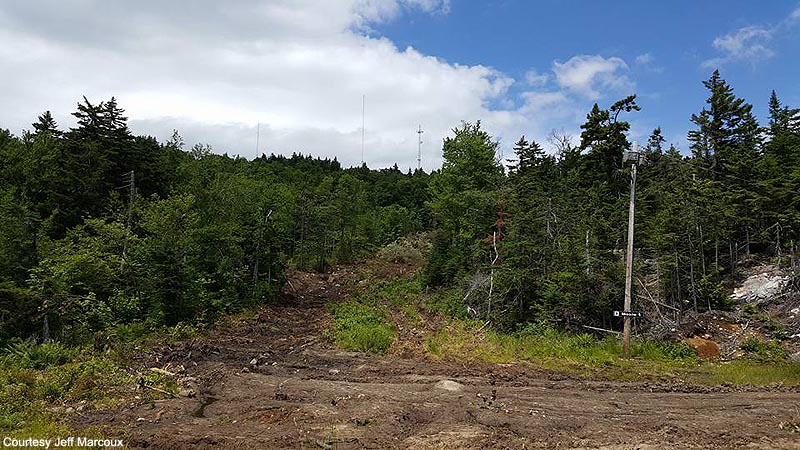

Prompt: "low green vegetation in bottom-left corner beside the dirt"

[0,323,201,437]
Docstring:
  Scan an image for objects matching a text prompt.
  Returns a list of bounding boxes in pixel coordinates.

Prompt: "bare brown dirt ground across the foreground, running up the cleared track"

[75,267,800,450]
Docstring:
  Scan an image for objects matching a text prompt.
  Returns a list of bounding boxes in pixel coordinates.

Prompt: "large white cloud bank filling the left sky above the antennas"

[0,0,630,169]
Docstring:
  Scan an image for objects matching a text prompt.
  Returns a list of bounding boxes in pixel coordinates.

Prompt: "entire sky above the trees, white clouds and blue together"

[0,0,800,169]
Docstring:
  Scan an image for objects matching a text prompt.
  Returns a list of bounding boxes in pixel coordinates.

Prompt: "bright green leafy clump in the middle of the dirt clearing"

[330,301,395,354]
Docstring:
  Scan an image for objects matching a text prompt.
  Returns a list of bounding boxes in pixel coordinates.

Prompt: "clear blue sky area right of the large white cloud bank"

[375,0,800,151]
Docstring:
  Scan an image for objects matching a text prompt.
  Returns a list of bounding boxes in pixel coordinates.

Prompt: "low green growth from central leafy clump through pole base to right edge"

[324,261,800,385]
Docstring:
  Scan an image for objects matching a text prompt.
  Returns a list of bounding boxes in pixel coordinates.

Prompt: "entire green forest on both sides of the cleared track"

[0,68,800,346]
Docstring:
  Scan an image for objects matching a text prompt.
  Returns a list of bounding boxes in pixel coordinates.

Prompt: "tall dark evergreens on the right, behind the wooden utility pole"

[425,71,800,327]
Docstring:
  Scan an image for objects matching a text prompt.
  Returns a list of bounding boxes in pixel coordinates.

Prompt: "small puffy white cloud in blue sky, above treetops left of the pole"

[553,55,633,100]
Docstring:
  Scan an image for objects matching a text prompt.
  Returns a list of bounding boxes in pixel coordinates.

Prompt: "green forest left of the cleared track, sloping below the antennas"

[0,98,430,343]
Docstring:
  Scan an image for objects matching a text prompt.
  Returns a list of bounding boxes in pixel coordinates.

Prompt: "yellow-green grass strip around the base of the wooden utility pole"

[425,320,800,385]
